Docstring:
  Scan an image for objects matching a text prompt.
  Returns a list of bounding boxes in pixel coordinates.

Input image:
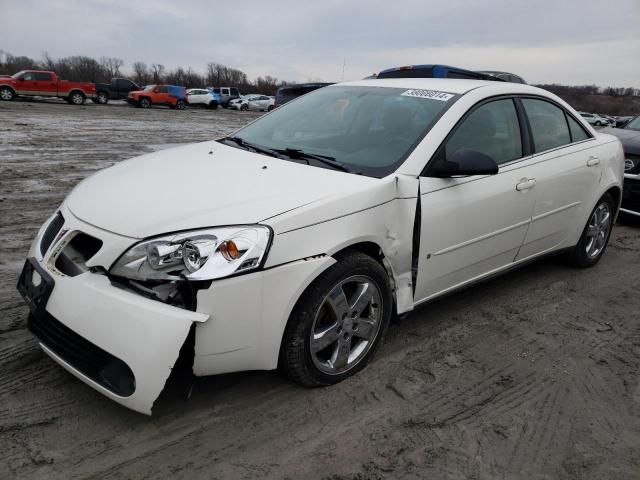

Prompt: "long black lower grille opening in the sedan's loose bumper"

[28,311,135,397]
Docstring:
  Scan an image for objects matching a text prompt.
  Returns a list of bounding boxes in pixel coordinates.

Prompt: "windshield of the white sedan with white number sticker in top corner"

[235,86,458,177]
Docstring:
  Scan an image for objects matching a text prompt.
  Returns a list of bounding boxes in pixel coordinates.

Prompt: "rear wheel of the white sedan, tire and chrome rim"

[567,193,615,268]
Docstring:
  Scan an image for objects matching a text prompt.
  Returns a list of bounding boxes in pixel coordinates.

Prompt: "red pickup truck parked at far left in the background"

[0,70,96,105]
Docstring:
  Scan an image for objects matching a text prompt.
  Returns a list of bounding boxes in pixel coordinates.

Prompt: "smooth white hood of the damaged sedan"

[66,142,379,238]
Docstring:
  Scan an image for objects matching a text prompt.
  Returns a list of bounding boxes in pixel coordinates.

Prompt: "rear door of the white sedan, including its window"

[517,97,602,260]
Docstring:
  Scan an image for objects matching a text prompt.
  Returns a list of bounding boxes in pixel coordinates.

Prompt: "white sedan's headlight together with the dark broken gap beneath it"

[109,225,271,311]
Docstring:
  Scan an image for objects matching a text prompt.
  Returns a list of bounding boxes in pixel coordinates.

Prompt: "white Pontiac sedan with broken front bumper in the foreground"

[18,78,624,414]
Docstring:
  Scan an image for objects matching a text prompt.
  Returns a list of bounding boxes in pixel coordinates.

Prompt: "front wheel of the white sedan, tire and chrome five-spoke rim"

[280,252,393,387]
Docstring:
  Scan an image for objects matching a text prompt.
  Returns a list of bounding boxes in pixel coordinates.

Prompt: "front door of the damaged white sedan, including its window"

[415,97,536,303]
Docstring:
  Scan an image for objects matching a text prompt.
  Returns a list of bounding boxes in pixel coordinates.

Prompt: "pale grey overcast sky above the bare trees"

[0,0,640,88]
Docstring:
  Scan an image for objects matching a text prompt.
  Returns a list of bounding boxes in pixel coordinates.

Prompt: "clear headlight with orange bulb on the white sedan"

[110,225,271,280]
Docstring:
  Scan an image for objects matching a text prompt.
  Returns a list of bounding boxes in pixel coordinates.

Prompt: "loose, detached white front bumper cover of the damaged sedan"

[18,211,209,415]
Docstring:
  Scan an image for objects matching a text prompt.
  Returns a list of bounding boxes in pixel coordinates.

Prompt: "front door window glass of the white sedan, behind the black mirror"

[445,99,522,165]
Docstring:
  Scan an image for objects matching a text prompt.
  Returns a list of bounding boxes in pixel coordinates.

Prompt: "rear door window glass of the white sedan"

[522,98,571,152]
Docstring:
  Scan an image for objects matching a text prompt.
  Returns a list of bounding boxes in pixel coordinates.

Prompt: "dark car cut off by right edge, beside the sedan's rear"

[600,116,640,221]
